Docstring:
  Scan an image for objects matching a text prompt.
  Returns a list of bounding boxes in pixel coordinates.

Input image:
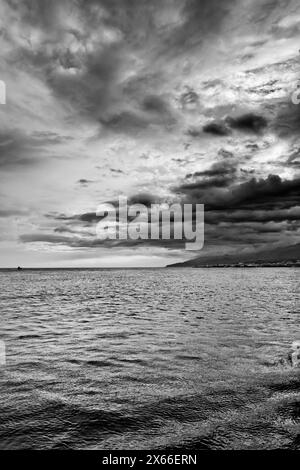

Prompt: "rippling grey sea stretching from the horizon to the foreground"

[0,268,300,452]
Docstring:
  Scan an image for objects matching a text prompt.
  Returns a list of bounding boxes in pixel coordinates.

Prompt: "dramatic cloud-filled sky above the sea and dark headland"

[0,0,300,267]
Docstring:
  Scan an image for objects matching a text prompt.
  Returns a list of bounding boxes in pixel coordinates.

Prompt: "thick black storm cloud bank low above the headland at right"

[170,166,300,252]
